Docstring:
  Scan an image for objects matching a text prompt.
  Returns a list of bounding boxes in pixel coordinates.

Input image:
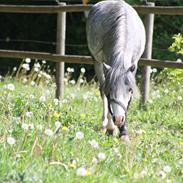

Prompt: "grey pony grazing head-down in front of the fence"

[86,0,145,140]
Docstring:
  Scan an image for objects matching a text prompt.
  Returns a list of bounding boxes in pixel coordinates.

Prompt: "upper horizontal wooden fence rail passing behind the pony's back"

[0,5,183,15]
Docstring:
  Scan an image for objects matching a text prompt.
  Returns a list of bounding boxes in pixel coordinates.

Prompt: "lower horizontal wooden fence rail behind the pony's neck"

[0,49,183,69]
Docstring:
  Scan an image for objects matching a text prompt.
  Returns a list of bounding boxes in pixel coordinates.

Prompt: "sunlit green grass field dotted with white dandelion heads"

[0,73,183,183]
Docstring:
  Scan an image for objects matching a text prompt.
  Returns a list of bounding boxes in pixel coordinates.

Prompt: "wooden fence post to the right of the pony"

[141,2,155,105]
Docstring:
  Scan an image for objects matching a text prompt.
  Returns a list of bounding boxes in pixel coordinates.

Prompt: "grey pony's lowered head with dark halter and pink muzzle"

[104,64,136,127]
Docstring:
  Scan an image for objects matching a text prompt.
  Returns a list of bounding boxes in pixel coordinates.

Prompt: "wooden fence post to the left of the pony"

[56,3,66,99]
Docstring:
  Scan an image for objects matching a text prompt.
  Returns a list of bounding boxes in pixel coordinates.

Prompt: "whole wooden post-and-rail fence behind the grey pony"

[0,3,183,104]
